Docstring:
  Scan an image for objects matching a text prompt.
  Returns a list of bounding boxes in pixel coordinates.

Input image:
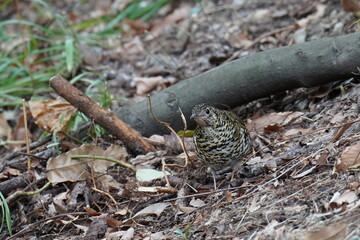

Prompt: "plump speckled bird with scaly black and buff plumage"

[191,104,251,170]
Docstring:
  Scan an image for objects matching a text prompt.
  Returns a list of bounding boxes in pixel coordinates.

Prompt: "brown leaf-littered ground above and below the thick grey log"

[0,0,360,240]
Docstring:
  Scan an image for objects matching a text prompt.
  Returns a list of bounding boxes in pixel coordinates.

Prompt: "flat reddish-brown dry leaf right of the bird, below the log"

[247,112,304,133]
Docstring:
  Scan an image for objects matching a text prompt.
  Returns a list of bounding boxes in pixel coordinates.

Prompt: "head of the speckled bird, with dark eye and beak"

[190,103,218,127]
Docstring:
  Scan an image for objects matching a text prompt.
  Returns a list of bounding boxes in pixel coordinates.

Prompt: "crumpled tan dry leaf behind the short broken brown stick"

[29,100,76,133]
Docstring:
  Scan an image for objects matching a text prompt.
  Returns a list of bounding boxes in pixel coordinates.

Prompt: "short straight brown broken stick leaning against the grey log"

[50,75,154,154]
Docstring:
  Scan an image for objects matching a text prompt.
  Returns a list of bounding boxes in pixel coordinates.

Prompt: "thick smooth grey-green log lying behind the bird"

[115,33,360,136]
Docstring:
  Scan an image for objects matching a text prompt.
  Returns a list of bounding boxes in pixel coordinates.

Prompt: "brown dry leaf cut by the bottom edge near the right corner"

[299,222,347,240]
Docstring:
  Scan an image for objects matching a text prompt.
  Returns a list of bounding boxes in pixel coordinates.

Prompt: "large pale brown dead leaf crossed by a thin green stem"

[46,144,127,184]
